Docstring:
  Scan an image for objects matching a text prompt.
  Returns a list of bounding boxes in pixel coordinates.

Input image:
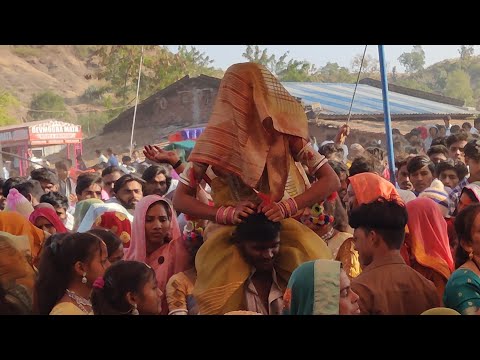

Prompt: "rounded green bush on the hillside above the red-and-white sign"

[28,90,68,120]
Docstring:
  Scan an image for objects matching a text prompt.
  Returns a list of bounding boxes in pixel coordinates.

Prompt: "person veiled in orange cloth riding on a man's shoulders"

[145,63,340,314]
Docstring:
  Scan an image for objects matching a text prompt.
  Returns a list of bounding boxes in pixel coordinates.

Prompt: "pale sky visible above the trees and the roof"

[168,45,470,72]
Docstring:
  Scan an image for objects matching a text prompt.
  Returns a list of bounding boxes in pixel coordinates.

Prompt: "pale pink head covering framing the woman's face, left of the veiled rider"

[125,195,190,314]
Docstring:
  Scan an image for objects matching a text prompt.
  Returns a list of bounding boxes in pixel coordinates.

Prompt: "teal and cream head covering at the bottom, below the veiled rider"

[283,260,341,315]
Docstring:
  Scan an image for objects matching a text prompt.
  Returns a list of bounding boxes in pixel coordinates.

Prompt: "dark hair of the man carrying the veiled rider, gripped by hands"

[232,213,281,242]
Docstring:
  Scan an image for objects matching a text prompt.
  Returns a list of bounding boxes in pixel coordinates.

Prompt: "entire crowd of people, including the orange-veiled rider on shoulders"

[0,63,480,315]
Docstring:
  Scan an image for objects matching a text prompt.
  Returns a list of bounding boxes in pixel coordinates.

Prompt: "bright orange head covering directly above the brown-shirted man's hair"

[348,173,403,205]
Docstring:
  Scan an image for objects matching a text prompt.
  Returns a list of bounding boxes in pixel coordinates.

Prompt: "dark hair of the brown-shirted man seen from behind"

[349,197,408,250]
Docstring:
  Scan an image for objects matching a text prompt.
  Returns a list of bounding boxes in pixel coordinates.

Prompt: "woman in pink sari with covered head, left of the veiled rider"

[125,195,190,315]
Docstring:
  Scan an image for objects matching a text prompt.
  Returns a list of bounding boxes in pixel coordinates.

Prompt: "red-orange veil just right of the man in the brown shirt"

[406,198,455,279]
